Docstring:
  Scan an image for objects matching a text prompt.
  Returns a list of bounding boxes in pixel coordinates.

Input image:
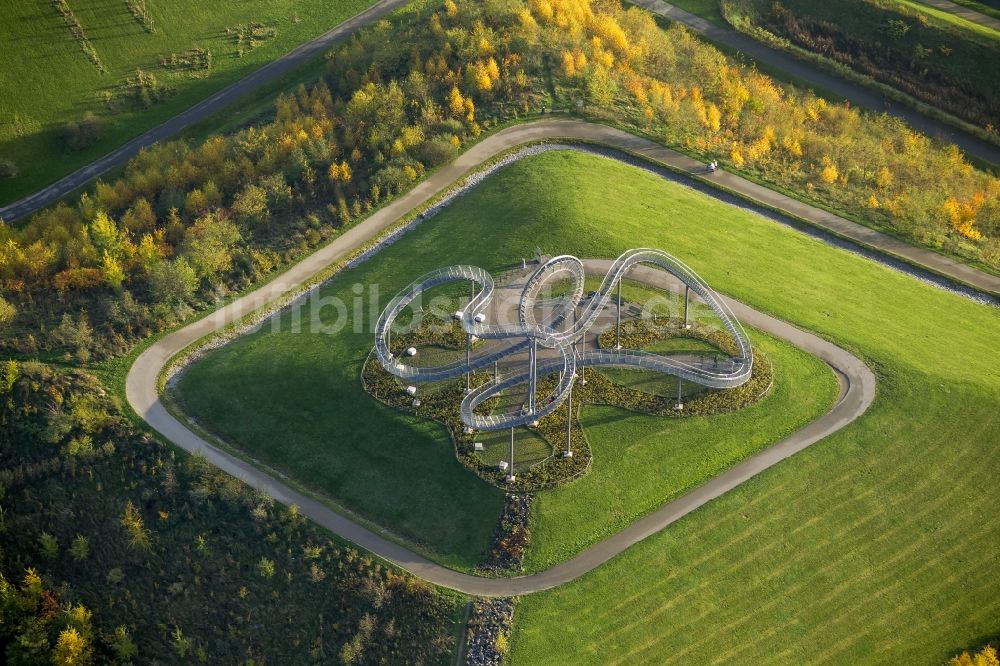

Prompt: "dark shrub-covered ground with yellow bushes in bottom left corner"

[0,361,457,664]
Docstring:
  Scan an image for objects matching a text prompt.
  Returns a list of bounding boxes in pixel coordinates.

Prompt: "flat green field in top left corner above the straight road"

[0,0,371,204]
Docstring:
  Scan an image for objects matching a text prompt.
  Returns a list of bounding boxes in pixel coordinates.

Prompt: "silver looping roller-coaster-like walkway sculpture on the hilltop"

[375,249,753,431]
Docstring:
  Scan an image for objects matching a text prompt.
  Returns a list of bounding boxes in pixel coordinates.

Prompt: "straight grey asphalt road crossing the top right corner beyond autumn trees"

[629,0,1000,165]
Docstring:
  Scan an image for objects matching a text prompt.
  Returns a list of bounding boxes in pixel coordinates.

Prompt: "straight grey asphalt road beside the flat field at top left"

[0,0,409,222]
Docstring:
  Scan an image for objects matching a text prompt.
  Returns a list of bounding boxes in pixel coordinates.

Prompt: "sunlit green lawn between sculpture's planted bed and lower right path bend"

[525,332,837,570]
